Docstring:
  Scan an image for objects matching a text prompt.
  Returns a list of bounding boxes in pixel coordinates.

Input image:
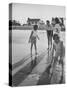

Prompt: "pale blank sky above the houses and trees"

[12,3,65,24]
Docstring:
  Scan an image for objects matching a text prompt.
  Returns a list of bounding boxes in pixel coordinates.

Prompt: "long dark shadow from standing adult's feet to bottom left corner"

[12,52,45,86]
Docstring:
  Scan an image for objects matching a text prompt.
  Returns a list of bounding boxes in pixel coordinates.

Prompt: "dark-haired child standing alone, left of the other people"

[29,25,39,56]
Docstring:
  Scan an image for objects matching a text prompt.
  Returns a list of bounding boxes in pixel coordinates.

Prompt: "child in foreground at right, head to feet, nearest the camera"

[51,34,63,83]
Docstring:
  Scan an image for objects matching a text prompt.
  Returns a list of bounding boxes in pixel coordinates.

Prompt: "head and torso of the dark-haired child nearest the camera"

[53,34,63,59]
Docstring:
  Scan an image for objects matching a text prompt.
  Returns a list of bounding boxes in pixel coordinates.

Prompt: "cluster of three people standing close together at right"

[46,18,65,84]
